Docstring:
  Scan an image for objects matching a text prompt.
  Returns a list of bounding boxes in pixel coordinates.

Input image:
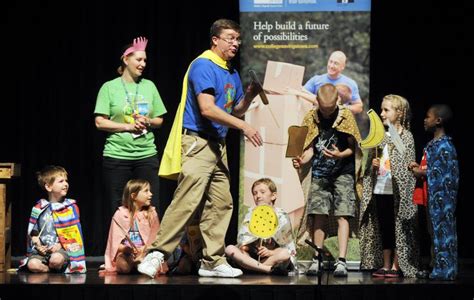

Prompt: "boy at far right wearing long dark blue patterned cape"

[410,104,459,280]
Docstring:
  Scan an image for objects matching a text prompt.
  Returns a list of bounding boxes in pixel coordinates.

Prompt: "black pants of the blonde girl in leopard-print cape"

[374,194,395,250]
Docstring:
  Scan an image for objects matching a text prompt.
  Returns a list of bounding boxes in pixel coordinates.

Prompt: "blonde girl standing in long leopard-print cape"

[359,95,419,277]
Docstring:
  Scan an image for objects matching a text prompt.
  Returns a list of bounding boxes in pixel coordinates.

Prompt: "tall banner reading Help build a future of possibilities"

[239,0,371,261]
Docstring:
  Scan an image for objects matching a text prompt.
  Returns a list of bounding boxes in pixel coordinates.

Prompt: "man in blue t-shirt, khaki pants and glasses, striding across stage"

[138,19,262,278]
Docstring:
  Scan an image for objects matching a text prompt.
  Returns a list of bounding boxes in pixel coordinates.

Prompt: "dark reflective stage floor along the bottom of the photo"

[0,263,474,300]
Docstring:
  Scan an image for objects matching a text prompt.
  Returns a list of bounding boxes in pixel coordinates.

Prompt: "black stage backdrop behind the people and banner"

[0,0,474,258]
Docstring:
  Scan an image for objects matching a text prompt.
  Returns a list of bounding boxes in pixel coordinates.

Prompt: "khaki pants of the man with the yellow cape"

[148,135,233,268]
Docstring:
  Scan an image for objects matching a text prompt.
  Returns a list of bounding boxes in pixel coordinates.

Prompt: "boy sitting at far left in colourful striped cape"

[20,166,86,273]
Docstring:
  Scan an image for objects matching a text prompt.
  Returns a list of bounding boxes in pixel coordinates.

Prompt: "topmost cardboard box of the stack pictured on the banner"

[263,60,304,94]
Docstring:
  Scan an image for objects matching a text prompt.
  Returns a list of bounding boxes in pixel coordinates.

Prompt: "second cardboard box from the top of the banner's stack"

[245,95,313,145]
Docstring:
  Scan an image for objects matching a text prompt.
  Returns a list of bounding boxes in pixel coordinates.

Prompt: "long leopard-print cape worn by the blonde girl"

[359,130,419,277]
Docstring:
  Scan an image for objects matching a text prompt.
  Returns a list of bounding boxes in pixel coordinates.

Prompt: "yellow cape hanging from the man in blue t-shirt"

[158,50,229,180]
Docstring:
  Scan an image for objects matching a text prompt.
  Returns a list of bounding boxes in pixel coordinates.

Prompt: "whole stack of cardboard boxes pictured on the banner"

[243,61,313,234]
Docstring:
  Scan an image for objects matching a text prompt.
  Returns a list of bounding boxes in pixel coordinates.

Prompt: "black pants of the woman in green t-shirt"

[102,155,160,220]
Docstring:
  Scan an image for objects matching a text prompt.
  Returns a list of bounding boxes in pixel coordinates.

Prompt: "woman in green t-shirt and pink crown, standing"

[94,37,166,225]
